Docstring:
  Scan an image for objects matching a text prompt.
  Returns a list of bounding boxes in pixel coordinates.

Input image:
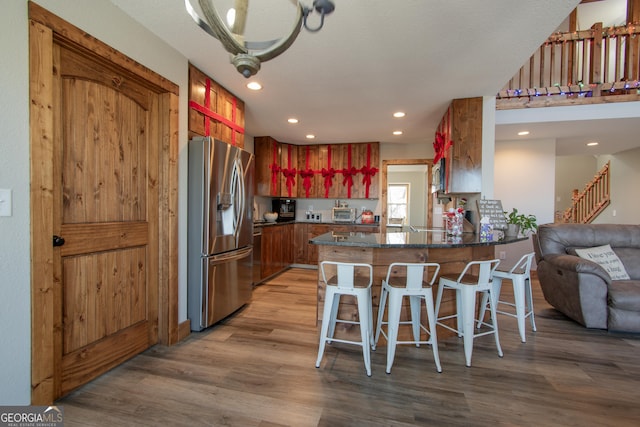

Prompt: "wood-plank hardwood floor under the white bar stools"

[57,269,640,427]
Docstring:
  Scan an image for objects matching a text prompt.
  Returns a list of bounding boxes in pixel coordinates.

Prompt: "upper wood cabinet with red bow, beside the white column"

[434,98,482,193]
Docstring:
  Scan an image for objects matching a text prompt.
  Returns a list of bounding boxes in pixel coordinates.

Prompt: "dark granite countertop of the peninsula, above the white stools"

[309,229,528,248]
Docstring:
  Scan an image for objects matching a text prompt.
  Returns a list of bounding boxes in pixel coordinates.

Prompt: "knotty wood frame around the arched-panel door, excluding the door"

[29,1,180,405]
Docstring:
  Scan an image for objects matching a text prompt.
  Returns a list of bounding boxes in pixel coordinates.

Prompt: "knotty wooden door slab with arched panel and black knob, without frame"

[53,44,159,396]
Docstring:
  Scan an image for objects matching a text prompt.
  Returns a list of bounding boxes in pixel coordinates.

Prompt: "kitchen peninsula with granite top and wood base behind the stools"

[310,229,527,342]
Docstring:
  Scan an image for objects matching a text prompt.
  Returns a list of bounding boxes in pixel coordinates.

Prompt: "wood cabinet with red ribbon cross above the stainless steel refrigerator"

[189,64,244,148]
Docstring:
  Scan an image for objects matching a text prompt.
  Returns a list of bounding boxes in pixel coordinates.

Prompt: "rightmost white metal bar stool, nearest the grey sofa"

[478,252,536,342]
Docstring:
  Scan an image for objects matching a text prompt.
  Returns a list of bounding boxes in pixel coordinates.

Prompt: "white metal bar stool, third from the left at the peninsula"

[436,259,503,366]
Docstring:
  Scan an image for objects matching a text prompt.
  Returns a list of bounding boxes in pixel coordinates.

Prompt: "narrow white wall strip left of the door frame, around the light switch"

[0,0,31,405]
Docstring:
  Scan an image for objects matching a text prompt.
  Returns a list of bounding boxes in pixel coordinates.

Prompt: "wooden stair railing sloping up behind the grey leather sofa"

[562,162,611,224]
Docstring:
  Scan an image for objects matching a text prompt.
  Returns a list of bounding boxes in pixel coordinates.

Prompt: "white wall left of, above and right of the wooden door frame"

[0,0,188,405]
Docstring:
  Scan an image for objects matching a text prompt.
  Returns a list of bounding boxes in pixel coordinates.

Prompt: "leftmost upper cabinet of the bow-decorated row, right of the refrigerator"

[253,136,282,197]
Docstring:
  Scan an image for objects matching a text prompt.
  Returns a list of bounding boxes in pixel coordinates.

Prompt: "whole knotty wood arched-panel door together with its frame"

[29,2,180,405]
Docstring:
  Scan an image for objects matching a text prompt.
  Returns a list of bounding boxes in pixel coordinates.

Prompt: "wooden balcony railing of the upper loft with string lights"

[497,23,640,108]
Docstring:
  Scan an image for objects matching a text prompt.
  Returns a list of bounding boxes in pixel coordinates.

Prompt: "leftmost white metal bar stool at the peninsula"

[316,261,373,376]
